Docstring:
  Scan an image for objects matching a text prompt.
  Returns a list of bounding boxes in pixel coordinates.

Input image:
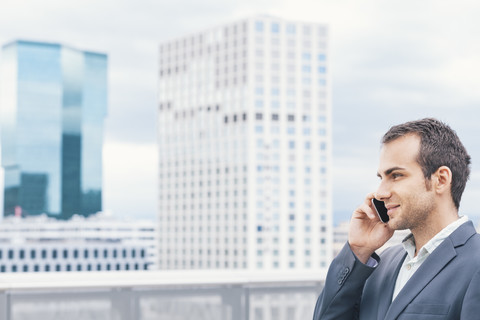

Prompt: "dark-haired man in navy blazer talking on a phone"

[313,119,480,320]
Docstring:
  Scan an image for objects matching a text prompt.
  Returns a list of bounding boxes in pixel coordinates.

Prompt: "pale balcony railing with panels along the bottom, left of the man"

[0,271,326,320]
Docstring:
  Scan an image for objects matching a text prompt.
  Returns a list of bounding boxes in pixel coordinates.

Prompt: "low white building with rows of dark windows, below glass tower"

[0,215,158,272]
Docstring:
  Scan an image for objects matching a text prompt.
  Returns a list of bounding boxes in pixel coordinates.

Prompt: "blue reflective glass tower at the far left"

[0,41,107,219]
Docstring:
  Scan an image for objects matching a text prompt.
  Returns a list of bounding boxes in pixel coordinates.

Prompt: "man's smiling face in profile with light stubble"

[376,134,435,230]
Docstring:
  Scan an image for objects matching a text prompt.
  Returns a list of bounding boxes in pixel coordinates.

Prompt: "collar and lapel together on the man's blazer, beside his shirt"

[385,221,476,320]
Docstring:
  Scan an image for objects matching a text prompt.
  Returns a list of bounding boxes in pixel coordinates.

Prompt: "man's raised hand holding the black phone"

[348,193,394,263]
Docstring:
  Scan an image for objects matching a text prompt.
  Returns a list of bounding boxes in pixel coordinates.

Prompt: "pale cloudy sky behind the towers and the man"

[0,0,480,224]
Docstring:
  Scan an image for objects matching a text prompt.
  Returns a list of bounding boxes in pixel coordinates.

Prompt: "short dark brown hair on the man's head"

[382,118,470,210]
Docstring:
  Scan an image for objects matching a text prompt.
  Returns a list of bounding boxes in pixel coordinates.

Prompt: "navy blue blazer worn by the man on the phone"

[313,221,480,320]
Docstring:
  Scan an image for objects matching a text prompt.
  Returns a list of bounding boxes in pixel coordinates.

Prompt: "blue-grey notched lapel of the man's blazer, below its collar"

[385,238,457,320]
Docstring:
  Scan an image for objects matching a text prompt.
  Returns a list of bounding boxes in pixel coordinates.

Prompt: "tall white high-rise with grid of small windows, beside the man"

[158,16,332,270]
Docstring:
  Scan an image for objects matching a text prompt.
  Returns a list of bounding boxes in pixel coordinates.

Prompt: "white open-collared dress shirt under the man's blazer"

[392,216,468,301]
